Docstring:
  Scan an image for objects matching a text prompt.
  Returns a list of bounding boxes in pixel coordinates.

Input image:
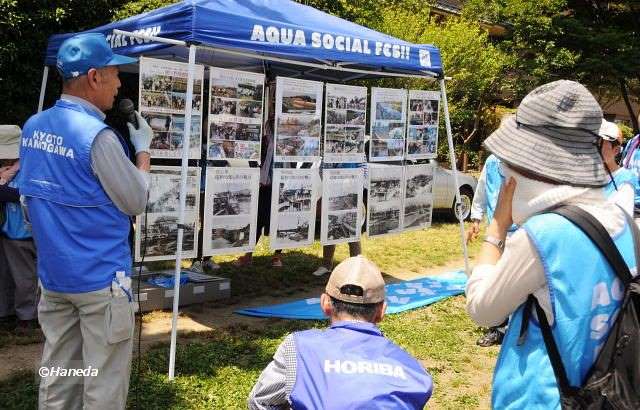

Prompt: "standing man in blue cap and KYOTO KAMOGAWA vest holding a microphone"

[19,33,152,410]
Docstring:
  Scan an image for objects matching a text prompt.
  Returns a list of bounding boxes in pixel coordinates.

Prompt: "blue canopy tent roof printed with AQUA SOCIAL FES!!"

[45,0,442,80]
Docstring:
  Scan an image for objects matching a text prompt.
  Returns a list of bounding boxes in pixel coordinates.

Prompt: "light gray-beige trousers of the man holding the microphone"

[38,287,135,410]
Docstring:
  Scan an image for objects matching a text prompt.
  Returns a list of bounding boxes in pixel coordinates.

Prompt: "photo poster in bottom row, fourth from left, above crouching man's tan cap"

[320,168,364,245]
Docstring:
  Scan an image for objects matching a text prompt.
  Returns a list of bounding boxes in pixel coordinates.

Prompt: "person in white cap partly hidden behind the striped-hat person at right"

[598,120,640,215]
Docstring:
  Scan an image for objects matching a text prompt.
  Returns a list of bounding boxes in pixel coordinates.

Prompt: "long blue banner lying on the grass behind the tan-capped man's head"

[235,270,467,320]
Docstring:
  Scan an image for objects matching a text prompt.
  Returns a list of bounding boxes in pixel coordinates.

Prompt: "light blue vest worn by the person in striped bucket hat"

[492,214,636,409]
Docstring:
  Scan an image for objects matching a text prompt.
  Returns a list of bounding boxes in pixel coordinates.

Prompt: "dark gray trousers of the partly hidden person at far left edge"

[0,237,38,320]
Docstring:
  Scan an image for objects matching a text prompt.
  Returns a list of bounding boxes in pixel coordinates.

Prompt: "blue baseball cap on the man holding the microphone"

[56,33,138,80]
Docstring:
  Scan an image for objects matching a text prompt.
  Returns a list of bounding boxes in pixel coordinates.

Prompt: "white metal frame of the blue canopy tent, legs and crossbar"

[105,29,469,380]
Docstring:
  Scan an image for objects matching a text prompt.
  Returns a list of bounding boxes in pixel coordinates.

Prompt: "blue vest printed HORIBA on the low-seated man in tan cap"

[289,322,433,410]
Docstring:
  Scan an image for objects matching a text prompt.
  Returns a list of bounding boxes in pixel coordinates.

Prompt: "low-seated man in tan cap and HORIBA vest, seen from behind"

[248,256,433,410]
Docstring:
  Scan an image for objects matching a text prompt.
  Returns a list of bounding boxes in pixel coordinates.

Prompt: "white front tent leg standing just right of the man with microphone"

[169,45,200,380]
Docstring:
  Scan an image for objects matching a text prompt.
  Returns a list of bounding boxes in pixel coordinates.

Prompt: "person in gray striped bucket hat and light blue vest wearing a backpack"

[466,80,637,409]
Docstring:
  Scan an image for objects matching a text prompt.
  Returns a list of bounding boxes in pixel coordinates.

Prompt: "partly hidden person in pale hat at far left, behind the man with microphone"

[0,125,38,333]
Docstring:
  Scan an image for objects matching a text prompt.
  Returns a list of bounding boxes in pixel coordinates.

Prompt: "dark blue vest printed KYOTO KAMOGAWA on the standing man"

[19,100,131,293]
